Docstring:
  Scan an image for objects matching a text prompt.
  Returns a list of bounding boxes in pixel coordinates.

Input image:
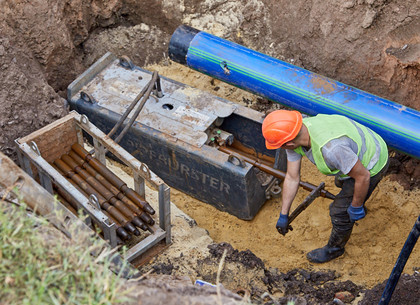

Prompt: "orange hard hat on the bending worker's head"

[262,110,302,149]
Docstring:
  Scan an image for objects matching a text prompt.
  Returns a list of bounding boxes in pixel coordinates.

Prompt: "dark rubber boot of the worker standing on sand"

[306,228,352,264]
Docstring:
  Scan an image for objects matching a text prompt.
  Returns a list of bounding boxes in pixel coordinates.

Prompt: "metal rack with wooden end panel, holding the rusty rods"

[15,111,171,262]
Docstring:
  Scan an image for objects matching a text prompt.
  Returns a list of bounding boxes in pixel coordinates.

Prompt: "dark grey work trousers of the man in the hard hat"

[328,159,389,248]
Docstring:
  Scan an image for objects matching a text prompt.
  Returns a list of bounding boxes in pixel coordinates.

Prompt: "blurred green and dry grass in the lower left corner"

[0,197,133,305]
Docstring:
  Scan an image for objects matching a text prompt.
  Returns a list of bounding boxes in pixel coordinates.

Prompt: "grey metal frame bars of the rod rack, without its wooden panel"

[15,111,171,262]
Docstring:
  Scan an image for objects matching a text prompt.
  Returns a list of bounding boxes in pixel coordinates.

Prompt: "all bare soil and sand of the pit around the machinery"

[0,0,420,304]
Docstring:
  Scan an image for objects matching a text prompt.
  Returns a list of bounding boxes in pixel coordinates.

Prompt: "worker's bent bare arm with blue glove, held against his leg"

[347,160,370,222]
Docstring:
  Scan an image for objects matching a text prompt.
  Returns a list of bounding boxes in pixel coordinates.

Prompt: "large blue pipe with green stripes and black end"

[168,25,420,159]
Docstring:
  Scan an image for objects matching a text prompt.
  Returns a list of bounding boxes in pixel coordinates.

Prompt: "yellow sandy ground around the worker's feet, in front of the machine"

[172,160,420,287]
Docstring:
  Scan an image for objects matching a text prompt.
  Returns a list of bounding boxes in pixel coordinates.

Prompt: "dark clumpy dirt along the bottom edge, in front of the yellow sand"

[143,242,420,305]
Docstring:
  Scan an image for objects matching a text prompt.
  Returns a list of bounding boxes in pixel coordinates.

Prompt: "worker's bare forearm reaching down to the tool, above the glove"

[281,159,302,215]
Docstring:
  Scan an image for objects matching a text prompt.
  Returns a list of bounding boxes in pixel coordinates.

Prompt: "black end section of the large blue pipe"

[168,24,200,65]
